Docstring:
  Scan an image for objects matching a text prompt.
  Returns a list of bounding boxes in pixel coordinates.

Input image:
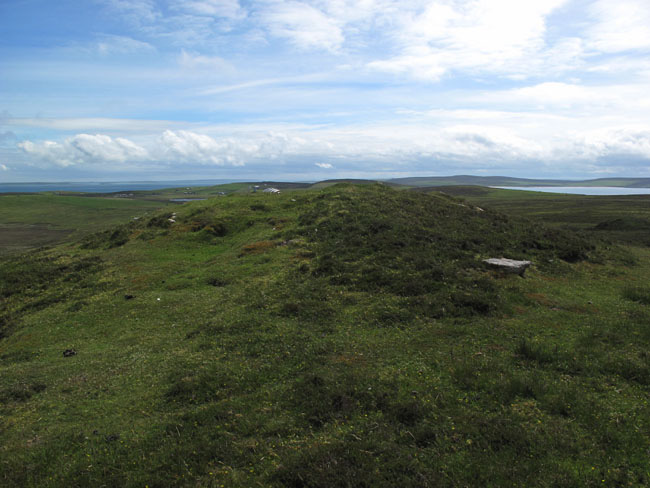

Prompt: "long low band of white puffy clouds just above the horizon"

[12,122,650,174]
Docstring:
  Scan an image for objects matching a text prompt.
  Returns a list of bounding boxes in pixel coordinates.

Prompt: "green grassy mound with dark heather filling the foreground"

[0,186,650,487]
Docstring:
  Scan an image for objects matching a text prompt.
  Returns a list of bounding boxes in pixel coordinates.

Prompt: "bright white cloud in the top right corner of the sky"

[587,0,650,53]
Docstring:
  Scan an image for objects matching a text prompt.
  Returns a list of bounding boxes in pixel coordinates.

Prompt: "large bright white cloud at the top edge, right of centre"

[368,0,568,81]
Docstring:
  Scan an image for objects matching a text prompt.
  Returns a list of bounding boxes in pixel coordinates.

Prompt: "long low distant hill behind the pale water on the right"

[387,175,650,188]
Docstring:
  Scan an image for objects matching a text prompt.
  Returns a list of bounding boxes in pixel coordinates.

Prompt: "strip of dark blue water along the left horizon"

[0,180,236,193]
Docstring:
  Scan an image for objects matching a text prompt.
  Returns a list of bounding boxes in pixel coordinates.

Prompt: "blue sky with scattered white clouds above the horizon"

[0,0,650,182]
